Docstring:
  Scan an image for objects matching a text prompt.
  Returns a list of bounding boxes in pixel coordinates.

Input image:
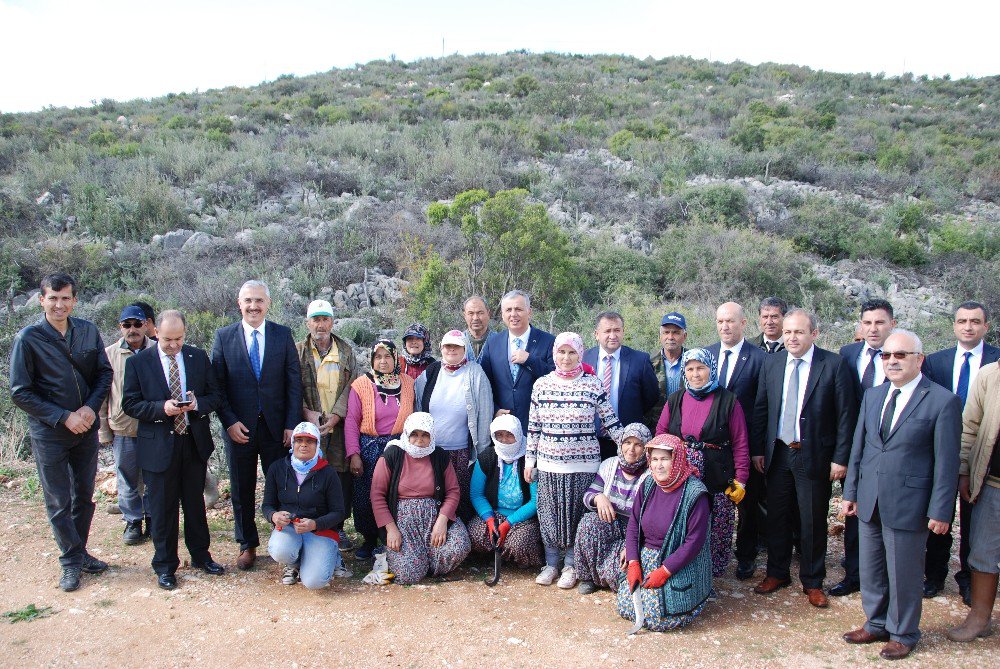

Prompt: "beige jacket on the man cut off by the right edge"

[958,362,1000,502]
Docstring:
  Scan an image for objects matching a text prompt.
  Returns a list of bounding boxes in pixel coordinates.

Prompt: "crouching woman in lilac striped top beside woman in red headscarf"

[574,423,653,595]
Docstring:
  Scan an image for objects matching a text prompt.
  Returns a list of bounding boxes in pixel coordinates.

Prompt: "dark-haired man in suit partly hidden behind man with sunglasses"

[830,299,896,597]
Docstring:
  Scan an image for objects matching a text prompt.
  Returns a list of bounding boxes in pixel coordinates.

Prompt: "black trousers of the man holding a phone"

[142,434,212,574]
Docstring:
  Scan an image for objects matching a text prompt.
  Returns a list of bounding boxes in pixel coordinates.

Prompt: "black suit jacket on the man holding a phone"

[122,345,222,472]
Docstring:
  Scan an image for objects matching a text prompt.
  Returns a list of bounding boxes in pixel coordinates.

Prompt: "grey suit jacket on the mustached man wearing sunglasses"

[844,377,962,531]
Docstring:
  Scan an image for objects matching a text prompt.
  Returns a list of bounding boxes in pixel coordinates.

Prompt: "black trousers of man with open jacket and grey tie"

[767,441,833,588]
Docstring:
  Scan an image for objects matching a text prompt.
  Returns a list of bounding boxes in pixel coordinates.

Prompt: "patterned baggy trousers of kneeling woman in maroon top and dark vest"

[385,497,472,585]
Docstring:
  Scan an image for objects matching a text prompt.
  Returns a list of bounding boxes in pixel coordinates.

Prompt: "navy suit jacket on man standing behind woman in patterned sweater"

[480,326,556,434]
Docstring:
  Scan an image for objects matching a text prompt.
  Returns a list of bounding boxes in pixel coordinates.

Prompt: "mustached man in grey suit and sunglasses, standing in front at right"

[842,330,962,660]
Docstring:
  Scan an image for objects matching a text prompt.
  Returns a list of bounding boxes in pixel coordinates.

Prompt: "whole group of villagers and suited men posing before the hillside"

[11,274,1000,659]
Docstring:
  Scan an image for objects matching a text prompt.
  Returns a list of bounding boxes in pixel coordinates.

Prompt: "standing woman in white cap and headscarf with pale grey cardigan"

[415,330,493,521]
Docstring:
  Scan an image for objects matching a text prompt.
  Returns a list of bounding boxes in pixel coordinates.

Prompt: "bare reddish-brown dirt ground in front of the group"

[0,474,1000,669]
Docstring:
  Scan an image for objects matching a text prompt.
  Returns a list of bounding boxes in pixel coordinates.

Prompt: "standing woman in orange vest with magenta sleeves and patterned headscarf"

[344,339,414,560]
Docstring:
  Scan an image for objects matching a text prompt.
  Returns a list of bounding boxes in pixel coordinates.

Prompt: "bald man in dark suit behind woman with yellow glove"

[708,302,767,581]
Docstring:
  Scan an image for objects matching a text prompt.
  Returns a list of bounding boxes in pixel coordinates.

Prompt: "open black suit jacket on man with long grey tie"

[750,346,858,481]
